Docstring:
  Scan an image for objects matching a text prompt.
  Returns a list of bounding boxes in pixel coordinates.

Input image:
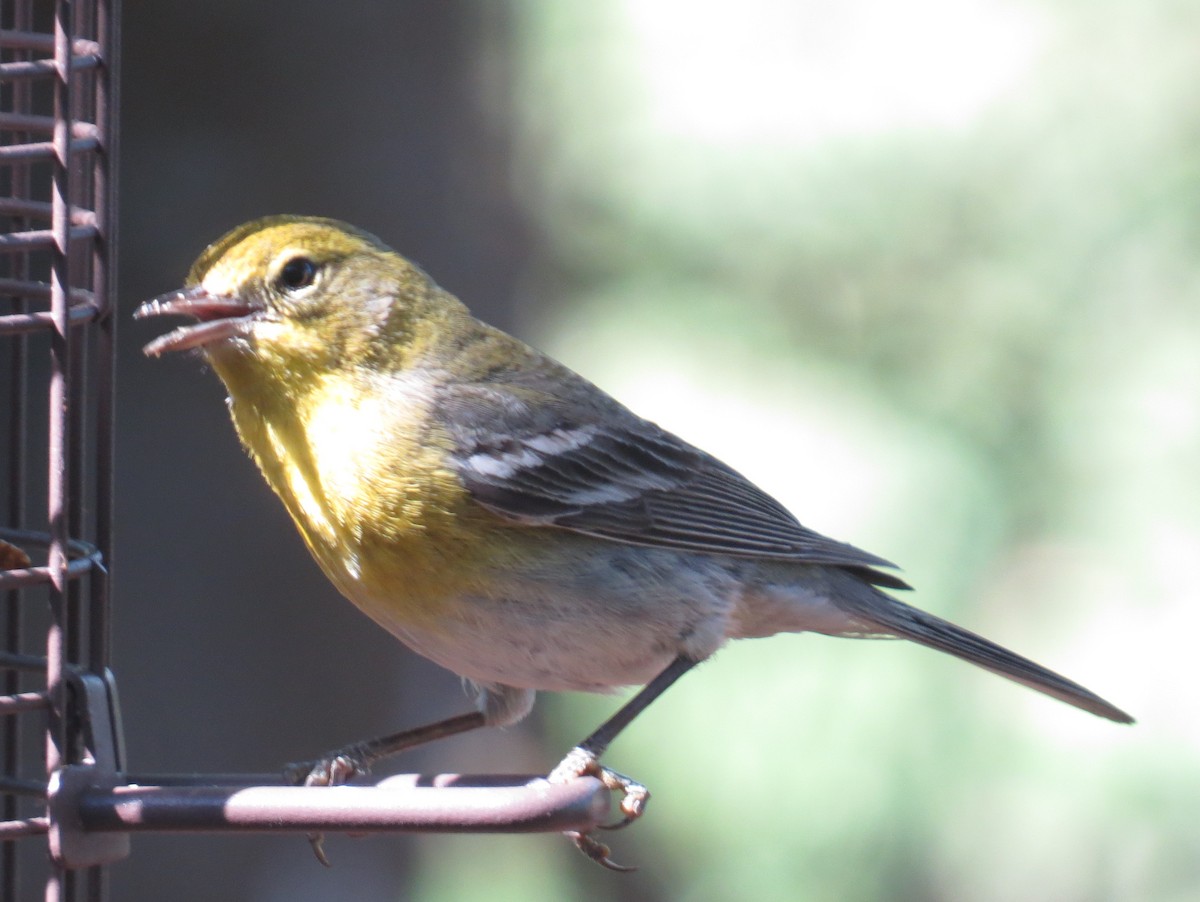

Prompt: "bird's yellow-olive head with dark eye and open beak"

[134,216,456,387]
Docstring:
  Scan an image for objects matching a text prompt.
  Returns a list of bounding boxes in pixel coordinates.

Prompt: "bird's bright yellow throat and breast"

[222,355,491,632]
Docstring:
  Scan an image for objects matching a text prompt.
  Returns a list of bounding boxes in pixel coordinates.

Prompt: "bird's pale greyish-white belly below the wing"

[343,542,739,692]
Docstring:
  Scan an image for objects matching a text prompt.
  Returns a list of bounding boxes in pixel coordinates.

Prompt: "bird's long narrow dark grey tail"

[838,583,1133,723]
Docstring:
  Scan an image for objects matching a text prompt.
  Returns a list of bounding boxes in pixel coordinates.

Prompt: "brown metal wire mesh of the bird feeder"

[0,0,118,900]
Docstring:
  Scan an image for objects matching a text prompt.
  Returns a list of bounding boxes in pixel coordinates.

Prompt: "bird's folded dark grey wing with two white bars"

[438,374,908,589]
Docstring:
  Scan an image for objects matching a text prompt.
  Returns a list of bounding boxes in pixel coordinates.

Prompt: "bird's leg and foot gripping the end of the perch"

[547,655,696,871]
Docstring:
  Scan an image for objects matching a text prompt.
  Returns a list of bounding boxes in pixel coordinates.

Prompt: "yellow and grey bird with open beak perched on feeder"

[134,215,1133,870]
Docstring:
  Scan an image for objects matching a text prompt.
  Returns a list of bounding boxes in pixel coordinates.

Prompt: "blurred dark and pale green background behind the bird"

[113,0,1200,902]
